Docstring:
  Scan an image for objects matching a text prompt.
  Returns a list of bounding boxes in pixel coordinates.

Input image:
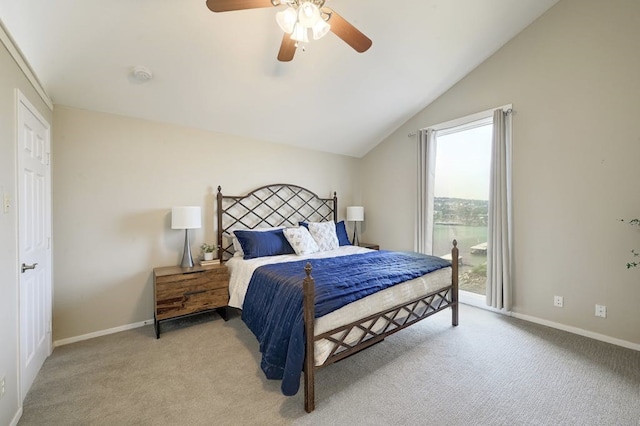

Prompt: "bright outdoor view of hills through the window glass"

[433,124,493,295]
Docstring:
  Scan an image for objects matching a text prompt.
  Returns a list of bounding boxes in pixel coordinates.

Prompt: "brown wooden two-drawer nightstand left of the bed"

[153,264,229,339]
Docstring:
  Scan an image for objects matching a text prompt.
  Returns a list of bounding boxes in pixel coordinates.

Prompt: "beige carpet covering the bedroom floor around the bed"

[19,305,640,426]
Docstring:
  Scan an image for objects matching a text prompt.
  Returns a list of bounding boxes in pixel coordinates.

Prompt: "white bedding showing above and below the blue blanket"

[226,246,451,365]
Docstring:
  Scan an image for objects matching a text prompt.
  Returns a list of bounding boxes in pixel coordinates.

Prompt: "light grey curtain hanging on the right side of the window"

[487,109,512,311]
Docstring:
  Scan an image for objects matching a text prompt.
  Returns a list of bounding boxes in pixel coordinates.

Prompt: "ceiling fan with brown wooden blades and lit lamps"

[207,0,372,62]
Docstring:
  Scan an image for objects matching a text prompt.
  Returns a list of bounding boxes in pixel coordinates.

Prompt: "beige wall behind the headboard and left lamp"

[53,105,358,340]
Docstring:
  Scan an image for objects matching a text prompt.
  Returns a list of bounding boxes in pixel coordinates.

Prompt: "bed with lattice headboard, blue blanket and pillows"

[217,184,458,412]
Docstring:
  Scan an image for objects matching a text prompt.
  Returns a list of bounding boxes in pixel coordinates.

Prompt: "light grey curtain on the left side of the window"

[415,129,436,254]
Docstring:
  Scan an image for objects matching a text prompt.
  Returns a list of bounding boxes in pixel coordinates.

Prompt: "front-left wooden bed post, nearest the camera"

[302,262,316,413]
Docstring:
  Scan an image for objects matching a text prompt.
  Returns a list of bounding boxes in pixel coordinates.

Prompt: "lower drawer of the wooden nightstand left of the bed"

[156,286,229,320]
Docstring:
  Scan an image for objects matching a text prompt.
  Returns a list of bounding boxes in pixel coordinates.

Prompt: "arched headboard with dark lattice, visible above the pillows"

[217,184,338,261]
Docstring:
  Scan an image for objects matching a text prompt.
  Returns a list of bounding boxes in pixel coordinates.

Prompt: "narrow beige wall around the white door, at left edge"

[0,43,51,425]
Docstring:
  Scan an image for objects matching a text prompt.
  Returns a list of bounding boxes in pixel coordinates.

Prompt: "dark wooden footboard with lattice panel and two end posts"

[303,240,459,413]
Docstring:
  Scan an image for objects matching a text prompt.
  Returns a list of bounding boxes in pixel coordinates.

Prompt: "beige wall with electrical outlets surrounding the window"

[361,0,640,346]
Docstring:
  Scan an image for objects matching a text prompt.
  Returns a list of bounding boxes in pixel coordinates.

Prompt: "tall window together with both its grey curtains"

[415,105,513,310]
